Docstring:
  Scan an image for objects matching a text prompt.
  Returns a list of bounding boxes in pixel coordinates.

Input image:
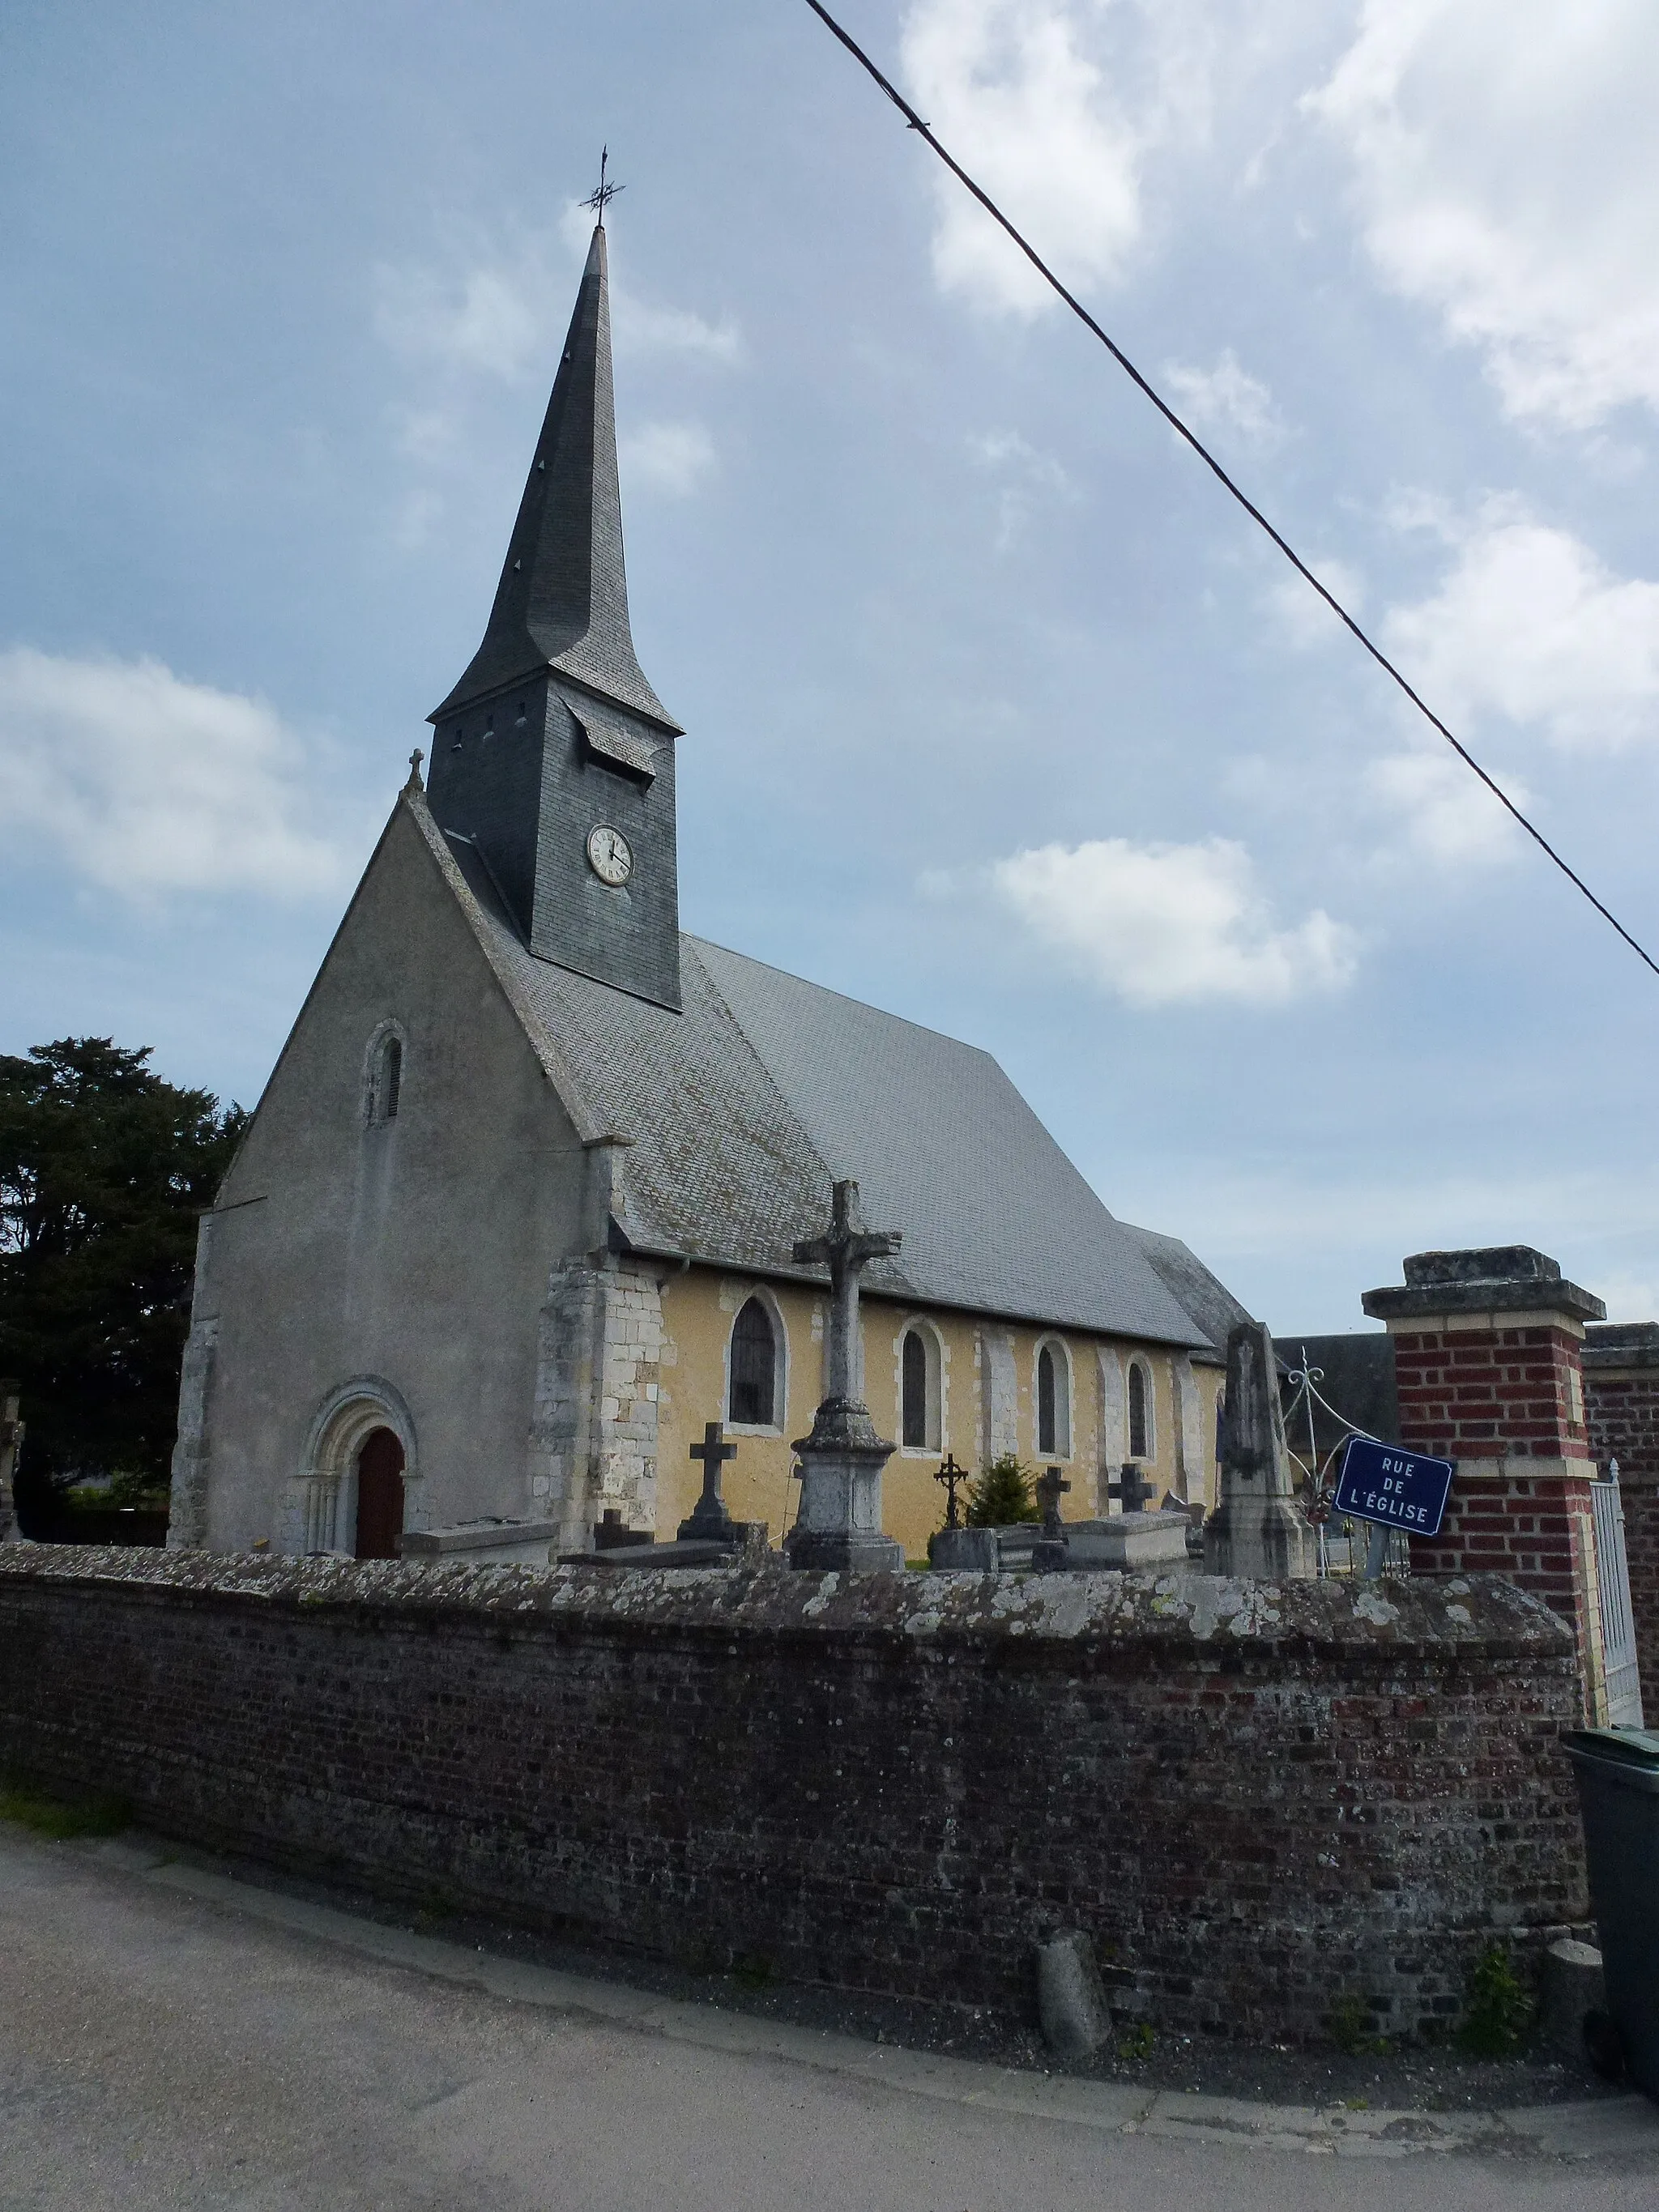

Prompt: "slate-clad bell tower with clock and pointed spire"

[427,215,681,1011]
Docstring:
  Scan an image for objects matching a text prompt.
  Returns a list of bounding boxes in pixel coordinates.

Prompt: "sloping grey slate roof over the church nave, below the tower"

[435,799,1226,1349]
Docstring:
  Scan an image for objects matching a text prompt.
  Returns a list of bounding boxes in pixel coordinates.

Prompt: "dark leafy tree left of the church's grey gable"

[0,1038,248,1507]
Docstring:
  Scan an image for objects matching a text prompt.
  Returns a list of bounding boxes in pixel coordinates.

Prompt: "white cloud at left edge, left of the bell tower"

[0,646,349,901]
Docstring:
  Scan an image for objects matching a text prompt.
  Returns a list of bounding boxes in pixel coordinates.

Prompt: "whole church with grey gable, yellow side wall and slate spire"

[168,210,1243,1562]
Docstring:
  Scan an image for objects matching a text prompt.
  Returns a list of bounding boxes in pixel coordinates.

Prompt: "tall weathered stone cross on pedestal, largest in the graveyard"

[787,1183,905,1575]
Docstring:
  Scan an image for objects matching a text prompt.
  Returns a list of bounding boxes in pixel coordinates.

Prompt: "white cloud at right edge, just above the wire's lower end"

[1384,497,1659,750]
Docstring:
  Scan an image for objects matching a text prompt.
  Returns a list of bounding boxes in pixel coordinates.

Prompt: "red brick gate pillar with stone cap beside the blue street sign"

[1360,1246,1606,1721]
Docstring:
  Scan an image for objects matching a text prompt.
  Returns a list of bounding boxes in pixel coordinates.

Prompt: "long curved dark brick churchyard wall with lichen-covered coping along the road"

[0,1546,1584,2042]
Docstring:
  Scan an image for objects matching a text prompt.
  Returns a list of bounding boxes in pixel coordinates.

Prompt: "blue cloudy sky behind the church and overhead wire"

[0,0,1659,1334]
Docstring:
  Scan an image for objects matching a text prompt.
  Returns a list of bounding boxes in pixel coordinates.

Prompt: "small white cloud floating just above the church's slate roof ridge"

[991,838,1358,1007]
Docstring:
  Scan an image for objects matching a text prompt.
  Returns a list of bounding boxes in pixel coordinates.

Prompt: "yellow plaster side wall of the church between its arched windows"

[657,1268,1219,1559]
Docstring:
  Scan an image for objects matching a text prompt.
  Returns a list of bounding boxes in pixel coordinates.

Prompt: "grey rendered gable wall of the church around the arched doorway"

[193,805,584,1550]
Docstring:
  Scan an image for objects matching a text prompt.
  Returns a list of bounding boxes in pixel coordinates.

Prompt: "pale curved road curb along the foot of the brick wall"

[78,1838,1659,2161]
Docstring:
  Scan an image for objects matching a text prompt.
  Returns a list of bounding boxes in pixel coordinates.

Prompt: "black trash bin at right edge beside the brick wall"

[1566,1728,1659,2103]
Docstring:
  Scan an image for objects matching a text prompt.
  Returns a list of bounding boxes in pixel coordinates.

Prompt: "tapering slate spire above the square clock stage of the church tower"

[429,221,679,735]
